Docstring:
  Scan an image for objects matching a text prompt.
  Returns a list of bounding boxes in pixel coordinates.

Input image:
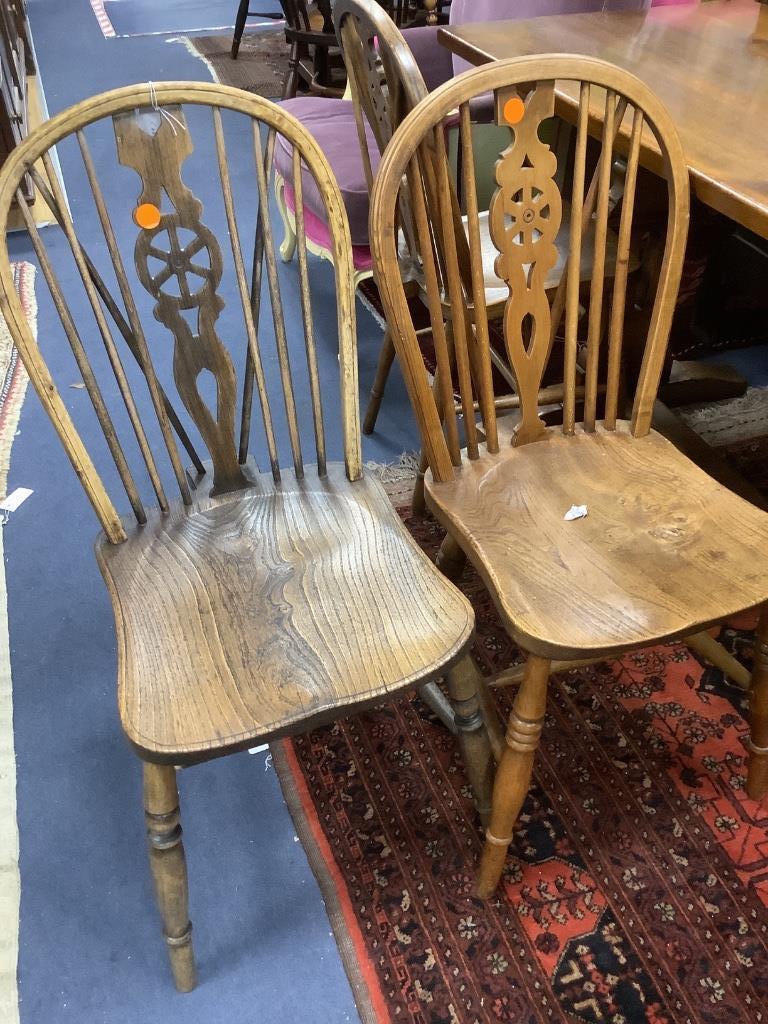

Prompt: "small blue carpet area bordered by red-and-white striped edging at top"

[104,0,281,36]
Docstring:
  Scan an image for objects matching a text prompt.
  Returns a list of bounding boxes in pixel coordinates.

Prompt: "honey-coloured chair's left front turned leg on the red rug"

[477,655,550,899]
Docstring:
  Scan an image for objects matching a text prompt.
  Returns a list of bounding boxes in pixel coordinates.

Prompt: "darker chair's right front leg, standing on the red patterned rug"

[446,654,496,825]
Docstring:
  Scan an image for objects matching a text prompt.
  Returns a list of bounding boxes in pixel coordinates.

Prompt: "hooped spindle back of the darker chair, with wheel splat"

[0,82,361,543]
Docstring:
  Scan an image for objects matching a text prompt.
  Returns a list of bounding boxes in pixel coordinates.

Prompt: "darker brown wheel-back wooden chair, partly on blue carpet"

[0,82,499,991]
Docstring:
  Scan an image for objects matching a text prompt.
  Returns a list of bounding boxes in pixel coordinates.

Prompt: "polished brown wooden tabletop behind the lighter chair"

[439,0,768,238]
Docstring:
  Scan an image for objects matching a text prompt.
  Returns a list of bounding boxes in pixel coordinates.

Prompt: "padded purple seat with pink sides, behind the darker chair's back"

[274,96,379,246]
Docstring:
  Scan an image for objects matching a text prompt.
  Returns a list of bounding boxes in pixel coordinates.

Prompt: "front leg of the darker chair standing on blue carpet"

[144,763,198,992]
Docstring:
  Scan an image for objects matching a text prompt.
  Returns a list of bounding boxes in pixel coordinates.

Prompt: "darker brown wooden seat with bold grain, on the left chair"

[96,465,473,764]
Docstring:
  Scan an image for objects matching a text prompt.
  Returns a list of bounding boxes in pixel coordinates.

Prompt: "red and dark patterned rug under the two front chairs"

[275,481,768,1024]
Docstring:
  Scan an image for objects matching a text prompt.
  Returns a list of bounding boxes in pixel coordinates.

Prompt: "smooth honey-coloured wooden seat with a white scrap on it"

[425,417,768,660]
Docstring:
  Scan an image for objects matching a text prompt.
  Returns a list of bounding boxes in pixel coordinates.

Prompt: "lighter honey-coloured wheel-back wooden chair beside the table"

[371,55,768,896]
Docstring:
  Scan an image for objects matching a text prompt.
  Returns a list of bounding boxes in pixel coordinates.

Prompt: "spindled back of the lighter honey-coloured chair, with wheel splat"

[371,55,689,482]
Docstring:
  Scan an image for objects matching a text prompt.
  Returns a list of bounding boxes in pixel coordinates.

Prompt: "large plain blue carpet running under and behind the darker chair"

[5,0,417,1024]
